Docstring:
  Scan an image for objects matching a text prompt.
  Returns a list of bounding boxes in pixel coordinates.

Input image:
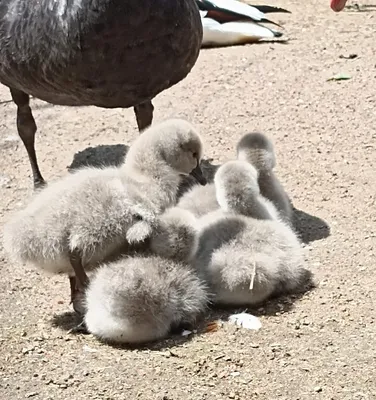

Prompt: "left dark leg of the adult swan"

[10,88,46,189]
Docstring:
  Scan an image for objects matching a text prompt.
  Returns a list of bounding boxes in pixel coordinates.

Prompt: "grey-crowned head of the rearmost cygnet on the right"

[236,132,276,171]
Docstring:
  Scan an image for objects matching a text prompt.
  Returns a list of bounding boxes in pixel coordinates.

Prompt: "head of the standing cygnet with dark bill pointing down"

[125,119,206,185]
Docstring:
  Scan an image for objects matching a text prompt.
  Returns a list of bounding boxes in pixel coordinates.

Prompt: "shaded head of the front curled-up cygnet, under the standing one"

[150,207,198,262]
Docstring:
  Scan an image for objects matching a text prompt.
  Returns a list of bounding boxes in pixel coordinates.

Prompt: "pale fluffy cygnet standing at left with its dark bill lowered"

[4,119,205,310]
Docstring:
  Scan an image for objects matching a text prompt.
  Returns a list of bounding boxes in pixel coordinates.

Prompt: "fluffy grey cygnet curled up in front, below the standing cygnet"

[84,209,209,344]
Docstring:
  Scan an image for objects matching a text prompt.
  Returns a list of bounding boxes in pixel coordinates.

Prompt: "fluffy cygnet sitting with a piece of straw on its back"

[193,161,311,306]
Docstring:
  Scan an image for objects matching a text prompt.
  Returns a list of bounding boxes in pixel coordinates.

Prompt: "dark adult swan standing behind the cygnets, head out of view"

[0,0,202,187]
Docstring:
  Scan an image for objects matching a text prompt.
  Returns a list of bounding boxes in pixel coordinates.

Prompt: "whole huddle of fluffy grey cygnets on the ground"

[4,119,311,344]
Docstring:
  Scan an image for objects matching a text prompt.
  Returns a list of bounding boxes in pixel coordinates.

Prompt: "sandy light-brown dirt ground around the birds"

[0,0,376,400]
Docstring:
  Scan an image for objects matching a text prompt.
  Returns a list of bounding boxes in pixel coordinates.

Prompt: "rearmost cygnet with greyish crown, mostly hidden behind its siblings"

[236,132,292,223]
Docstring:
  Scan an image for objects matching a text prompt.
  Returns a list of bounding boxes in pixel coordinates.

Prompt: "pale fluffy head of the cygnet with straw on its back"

[214,160,260,214]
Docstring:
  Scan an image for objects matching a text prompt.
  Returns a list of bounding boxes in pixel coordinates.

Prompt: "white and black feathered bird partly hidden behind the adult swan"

[196,0,290,47]
